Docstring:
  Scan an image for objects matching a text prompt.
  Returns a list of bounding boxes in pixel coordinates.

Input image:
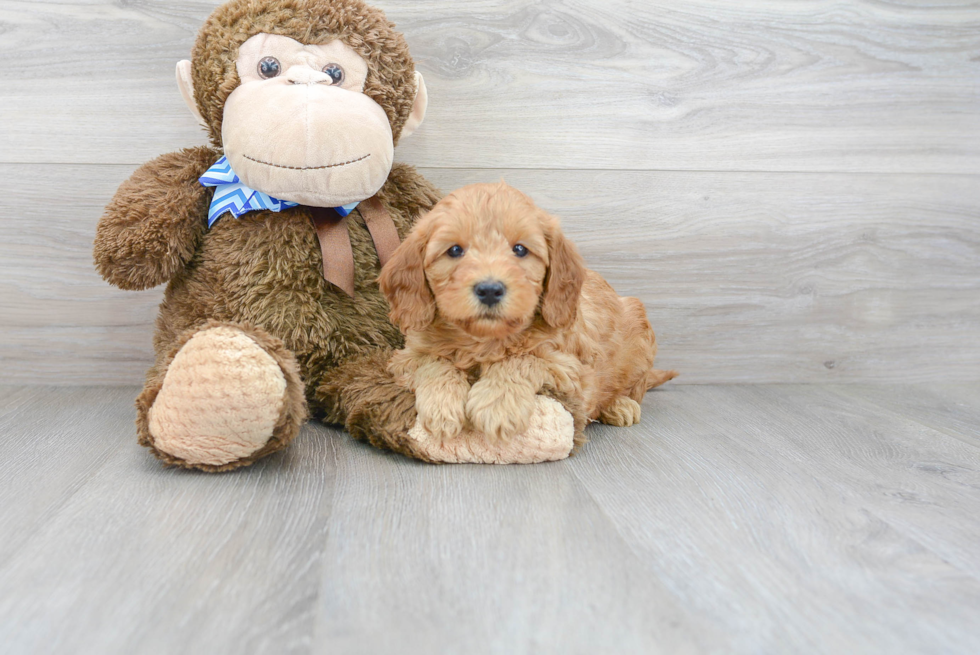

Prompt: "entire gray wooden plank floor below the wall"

[0,384,980,654]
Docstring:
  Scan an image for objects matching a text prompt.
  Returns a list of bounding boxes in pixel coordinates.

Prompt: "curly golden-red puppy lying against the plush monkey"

[379,183,676,439]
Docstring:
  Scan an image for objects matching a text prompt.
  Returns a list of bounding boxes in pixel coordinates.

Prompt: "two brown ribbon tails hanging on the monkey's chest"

[310,196,401,298]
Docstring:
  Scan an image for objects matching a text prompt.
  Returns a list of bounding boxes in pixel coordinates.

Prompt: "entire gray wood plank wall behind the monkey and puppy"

[0,0,980,384]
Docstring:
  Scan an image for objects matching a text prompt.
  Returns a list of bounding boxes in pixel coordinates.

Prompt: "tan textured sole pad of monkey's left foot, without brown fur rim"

[148,327,286,466]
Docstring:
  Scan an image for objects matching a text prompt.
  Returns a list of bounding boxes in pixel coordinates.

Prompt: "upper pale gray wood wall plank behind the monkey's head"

[0,0,980,173]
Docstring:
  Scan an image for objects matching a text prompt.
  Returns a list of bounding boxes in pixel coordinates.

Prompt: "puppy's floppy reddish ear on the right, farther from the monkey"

[541,218,585,328]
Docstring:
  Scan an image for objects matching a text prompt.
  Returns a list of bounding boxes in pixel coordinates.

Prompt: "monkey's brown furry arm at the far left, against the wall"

[94,146,221,290]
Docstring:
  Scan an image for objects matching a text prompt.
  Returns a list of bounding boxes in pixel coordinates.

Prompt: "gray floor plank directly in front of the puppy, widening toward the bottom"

[316,440,721,655]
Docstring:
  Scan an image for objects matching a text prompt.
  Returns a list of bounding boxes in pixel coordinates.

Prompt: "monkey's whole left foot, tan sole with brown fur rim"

[137,324,306,471]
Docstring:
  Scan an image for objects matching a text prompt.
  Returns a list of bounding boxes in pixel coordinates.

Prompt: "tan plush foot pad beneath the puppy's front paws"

[408,396,575,464]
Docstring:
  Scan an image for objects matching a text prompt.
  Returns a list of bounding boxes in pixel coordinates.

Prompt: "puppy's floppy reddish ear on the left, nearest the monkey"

[378,218,436,330]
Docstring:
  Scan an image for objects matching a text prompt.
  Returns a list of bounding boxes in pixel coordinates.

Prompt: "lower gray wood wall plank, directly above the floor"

[0,165,980,384]
